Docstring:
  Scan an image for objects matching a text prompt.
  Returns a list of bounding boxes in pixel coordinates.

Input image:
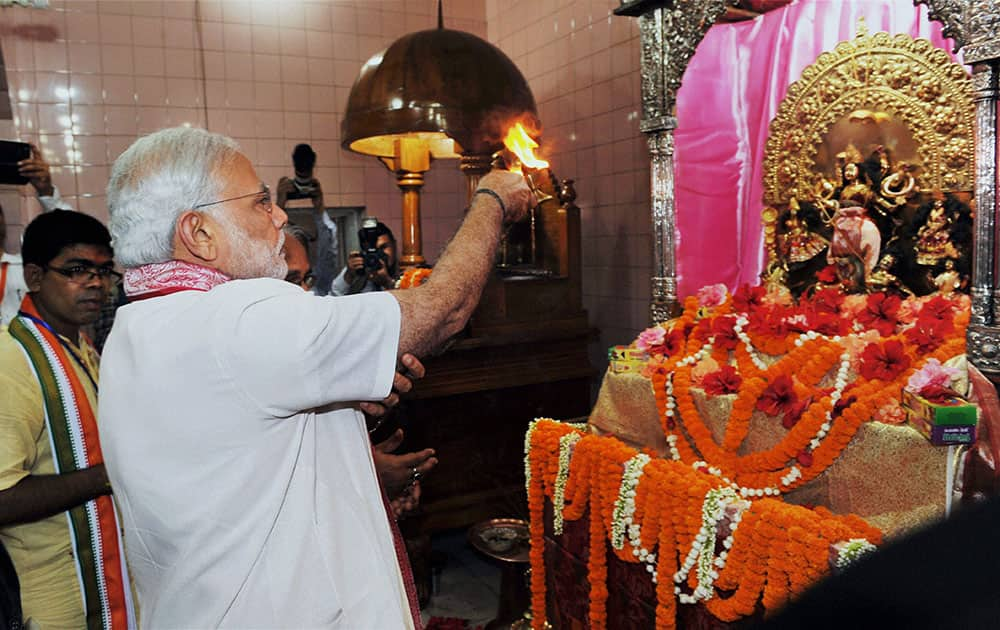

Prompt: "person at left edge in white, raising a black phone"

[0,145,73,331]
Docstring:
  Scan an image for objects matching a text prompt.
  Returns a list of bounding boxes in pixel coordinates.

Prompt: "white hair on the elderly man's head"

[108,127,240,267]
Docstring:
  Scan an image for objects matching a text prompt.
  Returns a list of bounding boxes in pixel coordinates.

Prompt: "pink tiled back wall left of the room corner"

[0,0,486,259]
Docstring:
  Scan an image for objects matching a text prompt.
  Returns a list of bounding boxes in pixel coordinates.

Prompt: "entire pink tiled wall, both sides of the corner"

[0,0,640,376]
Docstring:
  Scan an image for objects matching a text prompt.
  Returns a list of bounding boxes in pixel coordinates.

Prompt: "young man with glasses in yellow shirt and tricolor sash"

[0,210,135,628]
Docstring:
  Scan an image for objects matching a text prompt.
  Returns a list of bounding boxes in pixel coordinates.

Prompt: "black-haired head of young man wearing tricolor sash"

[21,210,118,337]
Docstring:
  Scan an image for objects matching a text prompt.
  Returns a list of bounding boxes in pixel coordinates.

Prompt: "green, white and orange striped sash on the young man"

[8,294,136,630]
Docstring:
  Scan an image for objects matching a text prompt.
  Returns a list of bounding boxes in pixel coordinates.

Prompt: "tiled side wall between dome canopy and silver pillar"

[486,0,652,367]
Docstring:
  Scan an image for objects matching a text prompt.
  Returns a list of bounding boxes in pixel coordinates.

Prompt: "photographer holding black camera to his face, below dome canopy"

[330,218,399,295]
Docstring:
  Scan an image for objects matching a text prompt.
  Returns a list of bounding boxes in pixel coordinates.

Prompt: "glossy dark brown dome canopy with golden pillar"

[341,5,538,266]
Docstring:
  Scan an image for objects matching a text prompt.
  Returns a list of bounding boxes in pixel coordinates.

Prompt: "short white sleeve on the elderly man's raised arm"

[215,280,400,417]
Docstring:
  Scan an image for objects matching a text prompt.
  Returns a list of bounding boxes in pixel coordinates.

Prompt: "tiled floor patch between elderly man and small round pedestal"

[421,530,500,628]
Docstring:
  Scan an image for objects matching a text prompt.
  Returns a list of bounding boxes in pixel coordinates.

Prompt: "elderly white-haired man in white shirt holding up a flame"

[100,128,532,629]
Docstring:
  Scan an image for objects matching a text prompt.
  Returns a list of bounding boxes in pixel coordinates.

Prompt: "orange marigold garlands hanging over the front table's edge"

[525,419,881,629]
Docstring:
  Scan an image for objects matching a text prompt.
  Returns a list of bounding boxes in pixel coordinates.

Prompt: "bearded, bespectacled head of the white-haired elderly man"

[108,127,288,278]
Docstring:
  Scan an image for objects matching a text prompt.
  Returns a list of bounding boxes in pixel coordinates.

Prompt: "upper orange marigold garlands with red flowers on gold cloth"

[635,287,969,497]
